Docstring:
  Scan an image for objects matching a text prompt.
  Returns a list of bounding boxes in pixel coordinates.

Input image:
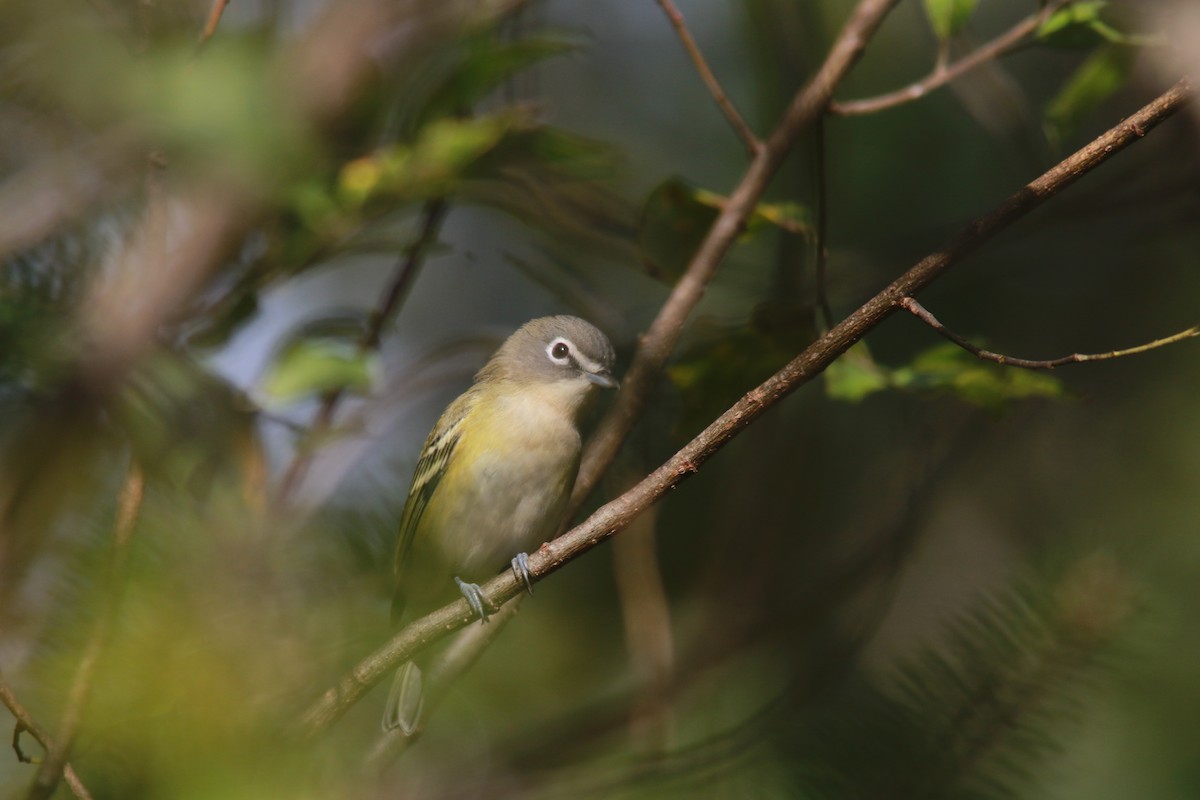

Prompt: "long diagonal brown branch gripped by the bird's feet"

[301,79,1192,736]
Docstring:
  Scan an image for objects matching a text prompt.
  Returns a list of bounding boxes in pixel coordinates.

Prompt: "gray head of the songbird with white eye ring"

[480,317,617,395]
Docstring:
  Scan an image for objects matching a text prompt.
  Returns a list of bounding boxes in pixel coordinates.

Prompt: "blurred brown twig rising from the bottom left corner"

[26,461,145,800]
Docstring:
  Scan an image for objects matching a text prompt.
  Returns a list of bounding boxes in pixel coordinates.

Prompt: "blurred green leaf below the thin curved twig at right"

[892,343,1069,409]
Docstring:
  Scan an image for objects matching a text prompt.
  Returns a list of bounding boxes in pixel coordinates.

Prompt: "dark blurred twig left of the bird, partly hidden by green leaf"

[275,198,449,509]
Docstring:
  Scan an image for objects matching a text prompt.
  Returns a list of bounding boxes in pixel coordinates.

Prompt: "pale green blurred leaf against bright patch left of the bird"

[262,337,378,405]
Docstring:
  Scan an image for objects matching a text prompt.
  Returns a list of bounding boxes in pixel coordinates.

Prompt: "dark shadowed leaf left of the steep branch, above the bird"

[637,178,718,284]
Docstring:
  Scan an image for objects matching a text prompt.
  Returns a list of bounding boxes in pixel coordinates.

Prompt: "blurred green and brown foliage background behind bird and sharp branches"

[0,0,1200,799]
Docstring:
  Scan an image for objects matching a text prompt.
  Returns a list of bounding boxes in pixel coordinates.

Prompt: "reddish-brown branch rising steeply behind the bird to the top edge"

[566,0,899,518]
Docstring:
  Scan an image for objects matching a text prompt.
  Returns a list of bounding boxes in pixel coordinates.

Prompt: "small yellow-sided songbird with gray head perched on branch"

[383,317,617,734]
